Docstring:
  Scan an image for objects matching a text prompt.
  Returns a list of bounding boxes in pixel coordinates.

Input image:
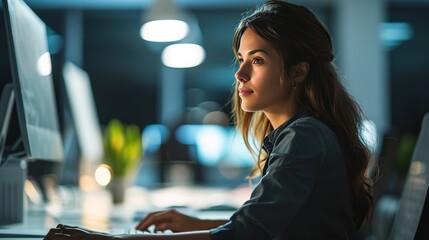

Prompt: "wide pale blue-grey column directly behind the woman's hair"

[335,0,390,149]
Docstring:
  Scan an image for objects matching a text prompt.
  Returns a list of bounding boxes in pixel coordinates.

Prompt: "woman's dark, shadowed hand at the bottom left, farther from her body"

[44,224,113,240]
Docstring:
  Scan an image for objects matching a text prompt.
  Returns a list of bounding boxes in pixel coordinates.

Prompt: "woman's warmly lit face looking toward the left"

[235,28,292,114]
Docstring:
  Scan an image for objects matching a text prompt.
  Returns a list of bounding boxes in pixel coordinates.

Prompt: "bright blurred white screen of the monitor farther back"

[63,62,103,163]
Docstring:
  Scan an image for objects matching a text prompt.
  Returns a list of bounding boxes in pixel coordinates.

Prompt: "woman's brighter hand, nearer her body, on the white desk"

[136,209,226,232]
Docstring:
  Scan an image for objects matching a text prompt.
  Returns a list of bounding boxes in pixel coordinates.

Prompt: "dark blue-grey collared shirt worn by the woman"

[210,111,357,240]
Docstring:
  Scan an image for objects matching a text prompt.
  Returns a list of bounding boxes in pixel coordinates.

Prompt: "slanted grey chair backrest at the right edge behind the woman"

[390,113,429,240]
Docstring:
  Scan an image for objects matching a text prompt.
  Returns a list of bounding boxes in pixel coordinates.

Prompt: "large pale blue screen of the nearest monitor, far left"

[3,0,64,161]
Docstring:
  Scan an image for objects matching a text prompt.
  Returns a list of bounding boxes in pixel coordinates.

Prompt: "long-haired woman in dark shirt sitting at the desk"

[43,1,373,240]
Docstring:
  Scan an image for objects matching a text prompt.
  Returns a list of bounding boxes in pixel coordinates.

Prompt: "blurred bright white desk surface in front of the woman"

[0,186,244,239]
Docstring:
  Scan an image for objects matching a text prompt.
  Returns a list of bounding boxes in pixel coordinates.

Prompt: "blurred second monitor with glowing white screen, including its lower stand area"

[62,62,104,188]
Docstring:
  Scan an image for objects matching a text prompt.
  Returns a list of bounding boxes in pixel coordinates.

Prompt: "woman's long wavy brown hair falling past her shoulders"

[232,1,374,232]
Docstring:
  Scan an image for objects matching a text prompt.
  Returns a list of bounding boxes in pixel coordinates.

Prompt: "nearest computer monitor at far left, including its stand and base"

[0,0,64,225]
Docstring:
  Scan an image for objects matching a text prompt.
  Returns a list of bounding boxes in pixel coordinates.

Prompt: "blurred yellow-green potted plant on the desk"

[103,119,143,203]
